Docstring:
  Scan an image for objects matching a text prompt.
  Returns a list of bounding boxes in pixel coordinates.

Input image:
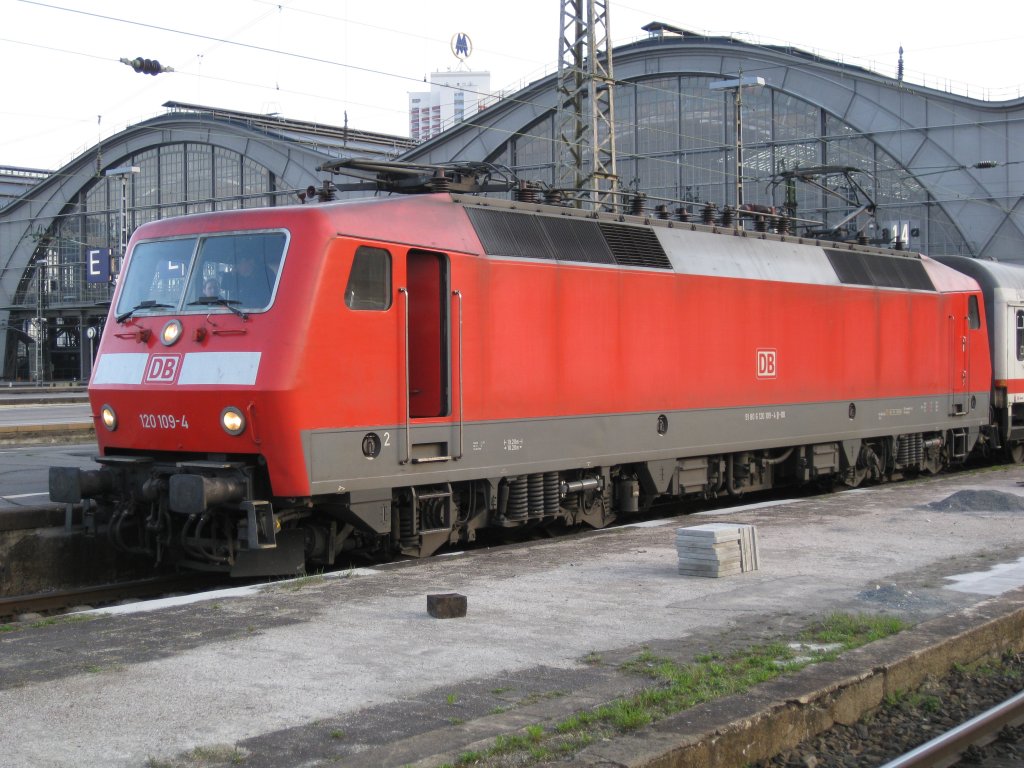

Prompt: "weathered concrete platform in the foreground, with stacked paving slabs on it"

[0,467,1024,768]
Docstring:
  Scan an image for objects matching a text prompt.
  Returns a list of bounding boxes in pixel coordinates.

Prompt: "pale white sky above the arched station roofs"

[0,0,1024,169]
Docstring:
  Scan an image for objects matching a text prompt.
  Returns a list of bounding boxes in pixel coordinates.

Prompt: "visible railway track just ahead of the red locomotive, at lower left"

[0,573,220,623]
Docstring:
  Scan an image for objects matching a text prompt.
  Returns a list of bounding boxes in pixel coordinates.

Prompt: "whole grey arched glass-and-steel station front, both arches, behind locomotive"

[0,30,1024,381]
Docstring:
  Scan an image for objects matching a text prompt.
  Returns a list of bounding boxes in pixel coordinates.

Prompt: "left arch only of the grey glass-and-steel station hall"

[0,102,414,382]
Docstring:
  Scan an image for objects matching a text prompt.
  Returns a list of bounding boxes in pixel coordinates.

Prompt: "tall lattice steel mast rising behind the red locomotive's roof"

[555,0,618,210]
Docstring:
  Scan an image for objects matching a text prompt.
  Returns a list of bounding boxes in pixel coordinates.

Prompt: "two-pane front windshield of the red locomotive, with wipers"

[116,231,288,317]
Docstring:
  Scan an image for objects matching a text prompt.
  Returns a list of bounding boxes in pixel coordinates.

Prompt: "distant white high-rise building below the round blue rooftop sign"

[409,71,490,141]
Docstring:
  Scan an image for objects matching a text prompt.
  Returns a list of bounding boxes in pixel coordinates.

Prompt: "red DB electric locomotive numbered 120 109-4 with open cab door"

[50,194,991,574]
